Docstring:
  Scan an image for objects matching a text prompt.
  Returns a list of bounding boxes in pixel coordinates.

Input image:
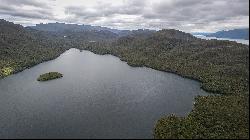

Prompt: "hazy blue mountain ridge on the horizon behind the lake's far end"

[26,23,121,41]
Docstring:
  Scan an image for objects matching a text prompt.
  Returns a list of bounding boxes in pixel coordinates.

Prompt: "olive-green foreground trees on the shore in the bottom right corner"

[154,95,249,139]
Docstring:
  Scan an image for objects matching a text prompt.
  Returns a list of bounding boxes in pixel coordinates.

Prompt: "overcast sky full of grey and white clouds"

[0,0,249,32]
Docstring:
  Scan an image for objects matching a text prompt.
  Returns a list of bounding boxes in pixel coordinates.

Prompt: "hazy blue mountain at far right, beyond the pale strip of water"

[206,28,249,40]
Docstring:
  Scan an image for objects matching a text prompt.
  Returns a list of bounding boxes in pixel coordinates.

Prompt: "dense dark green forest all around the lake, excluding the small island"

[0,20,249,138]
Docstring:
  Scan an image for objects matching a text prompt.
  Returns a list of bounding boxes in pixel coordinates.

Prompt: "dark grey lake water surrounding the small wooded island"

[0,49,207,138]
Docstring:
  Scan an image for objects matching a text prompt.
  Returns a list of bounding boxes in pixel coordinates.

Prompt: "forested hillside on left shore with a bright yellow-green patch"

[0,20,66,78]
